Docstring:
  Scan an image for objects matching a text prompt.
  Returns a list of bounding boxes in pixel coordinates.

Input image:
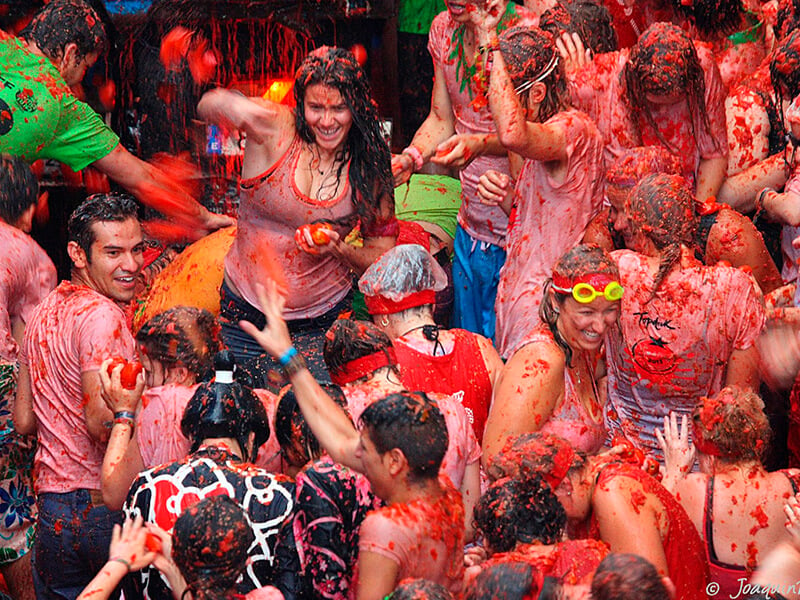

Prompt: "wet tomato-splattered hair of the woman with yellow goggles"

[539,244,619,367]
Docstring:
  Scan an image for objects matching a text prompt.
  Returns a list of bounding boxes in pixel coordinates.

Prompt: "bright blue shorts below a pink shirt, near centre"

[452,225,506,342]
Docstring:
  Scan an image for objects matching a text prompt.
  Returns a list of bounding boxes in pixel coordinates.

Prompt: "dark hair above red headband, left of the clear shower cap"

[322,319,396,372]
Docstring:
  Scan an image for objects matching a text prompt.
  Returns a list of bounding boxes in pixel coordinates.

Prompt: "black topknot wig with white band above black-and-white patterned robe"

[181,350,269,462]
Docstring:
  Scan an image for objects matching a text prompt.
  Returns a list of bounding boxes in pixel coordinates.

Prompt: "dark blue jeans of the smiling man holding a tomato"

[33,490,122,600]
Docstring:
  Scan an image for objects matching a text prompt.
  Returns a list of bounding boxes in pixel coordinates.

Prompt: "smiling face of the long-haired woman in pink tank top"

[303,83,353,152]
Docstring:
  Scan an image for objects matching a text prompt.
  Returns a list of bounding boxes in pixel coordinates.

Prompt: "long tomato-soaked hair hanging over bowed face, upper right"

[621,23,716,154]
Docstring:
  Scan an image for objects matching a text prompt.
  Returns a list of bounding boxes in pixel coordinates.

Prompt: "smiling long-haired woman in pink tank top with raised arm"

[198,47,397,387]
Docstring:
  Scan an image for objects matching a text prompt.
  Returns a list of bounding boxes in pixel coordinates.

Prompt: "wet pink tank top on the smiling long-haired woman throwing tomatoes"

[225,137,355,320]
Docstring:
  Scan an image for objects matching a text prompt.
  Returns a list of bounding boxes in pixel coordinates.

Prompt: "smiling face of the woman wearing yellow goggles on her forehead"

[552,290,619,351]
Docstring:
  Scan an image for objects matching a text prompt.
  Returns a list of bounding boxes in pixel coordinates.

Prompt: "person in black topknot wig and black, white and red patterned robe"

[123,351,295,600]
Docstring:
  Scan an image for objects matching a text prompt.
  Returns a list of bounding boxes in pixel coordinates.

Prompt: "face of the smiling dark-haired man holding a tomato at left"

[73,219,144,303]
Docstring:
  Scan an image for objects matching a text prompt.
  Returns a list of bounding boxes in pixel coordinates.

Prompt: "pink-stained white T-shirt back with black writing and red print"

[606,250,764,456]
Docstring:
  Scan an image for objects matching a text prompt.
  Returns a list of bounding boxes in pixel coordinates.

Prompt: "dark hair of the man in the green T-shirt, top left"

[19,0,108,59]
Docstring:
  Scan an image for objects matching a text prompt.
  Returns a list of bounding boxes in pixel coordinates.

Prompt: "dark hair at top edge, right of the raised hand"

[539,0,619,54]
